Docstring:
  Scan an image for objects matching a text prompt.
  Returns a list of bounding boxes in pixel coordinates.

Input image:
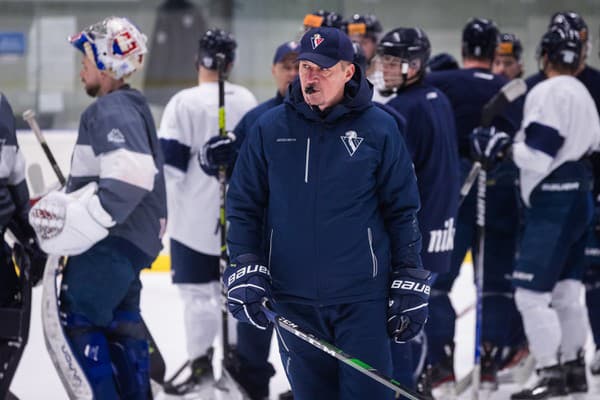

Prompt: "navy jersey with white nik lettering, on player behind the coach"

[386,84,460,273]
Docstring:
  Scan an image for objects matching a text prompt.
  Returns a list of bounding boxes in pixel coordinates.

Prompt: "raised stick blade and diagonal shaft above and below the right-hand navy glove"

[458,78,527,207]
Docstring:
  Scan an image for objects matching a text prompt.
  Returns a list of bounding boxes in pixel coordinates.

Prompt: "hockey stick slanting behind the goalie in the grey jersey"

[23,110,167,385]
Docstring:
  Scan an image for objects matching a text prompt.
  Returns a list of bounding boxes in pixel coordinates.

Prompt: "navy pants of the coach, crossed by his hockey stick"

[273,299,394,400]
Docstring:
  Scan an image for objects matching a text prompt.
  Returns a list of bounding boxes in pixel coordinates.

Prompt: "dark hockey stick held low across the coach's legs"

[262,299,430,400]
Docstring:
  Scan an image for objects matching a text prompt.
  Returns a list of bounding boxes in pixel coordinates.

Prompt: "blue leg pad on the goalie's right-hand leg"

[108,311,150,400]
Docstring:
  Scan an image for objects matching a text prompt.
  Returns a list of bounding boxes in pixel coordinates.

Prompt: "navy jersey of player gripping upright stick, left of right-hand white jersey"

[425,68,519,158]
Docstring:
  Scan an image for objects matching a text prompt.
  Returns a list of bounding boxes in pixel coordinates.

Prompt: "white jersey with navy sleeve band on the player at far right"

[513,75,600,206]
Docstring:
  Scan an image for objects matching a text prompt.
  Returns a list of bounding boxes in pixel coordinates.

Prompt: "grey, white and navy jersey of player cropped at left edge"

[0,93,29,229]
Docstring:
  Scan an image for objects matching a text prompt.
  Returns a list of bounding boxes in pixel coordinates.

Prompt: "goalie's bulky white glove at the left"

[29,182,115,256]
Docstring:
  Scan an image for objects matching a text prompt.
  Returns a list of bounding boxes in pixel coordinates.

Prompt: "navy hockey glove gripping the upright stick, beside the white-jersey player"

[470,127,512,171]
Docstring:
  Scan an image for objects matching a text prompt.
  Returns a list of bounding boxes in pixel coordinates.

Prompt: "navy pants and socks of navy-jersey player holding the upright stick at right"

[425,163,521,364]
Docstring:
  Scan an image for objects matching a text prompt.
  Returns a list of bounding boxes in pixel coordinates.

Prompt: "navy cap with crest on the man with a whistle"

[298,27,354,68]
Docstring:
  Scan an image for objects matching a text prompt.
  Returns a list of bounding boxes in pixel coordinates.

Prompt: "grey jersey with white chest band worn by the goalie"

[67,85,167,258]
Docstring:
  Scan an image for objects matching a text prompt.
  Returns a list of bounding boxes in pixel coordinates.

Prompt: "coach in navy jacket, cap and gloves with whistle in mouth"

[223,28,430,400]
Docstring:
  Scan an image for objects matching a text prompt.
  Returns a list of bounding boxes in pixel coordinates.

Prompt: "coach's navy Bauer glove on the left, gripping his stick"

[223,254,271,330]
